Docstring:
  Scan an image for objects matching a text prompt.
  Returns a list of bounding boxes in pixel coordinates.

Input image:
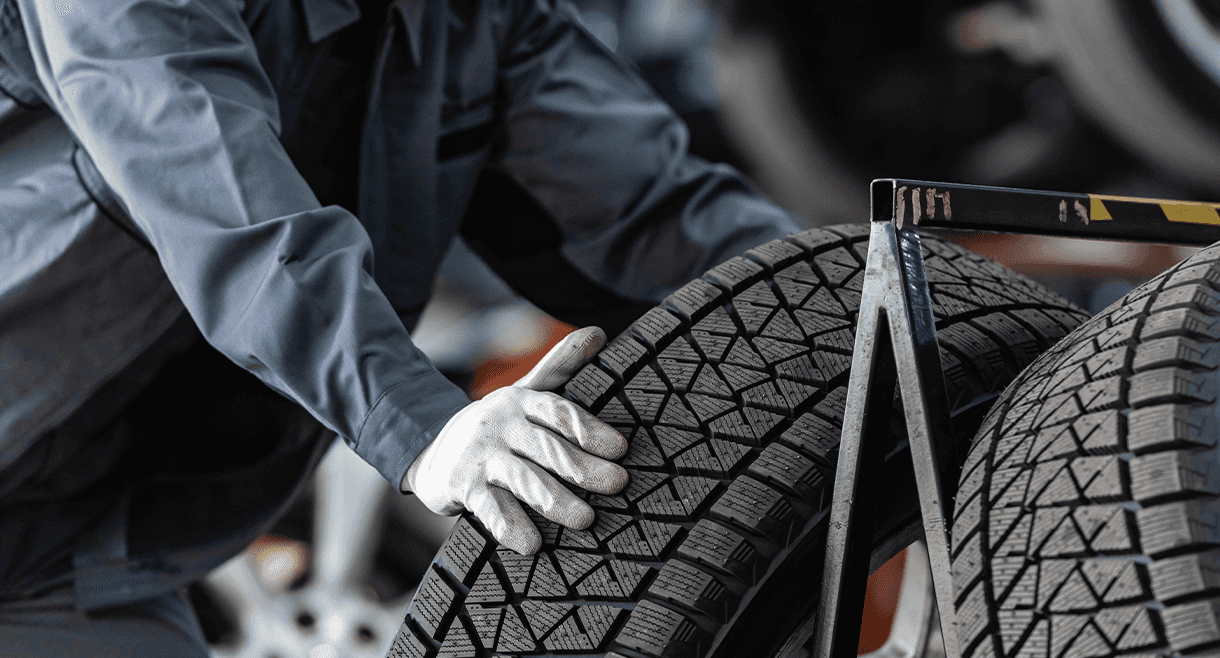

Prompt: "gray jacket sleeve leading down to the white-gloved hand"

[18,0,468,486]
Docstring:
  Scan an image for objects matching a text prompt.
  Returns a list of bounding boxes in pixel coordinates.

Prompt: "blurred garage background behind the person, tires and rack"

[192,0,1220,658]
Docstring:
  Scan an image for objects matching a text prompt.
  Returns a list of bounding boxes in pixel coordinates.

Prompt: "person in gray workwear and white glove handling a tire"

[0,0,798,656]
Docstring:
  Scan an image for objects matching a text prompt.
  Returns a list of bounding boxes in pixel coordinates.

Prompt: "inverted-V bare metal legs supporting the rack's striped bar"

[810,220,960,658]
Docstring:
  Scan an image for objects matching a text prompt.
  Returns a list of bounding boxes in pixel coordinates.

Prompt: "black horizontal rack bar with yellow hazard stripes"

[872,178,1220,245]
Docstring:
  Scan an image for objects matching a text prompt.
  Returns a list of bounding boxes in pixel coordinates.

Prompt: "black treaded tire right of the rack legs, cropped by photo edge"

[953,244,1220,658]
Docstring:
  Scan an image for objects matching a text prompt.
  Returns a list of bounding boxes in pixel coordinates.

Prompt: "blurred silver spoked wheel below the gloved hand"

[190,441,454,658]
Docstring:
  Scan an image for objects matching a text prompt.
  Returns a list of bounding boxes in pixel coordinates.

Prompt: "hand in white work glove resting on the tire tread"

[401,327,627,554]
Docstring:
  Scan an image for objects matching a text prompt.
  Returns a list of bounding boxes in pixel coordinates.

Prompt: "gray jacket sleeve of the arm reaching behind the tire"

[480,0,799,308]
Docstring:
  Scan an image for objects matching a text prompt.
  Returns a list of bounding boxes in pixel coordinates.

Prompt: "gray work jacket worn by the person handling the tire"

[0,0,797,605]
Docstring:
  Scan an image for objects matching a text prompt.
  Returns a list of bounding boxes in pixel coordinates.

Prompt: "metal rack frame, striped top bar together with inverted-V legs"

[810,178,1220,658]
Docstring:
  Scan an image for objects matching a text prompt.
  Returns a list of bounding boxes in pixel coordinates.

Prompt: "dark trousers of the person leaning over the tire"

[0,316,333,658]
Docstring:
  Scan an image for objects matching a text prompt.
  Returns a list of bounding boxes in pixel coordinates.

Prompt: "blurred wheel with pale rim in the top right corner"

[1033,0,1220,194]
